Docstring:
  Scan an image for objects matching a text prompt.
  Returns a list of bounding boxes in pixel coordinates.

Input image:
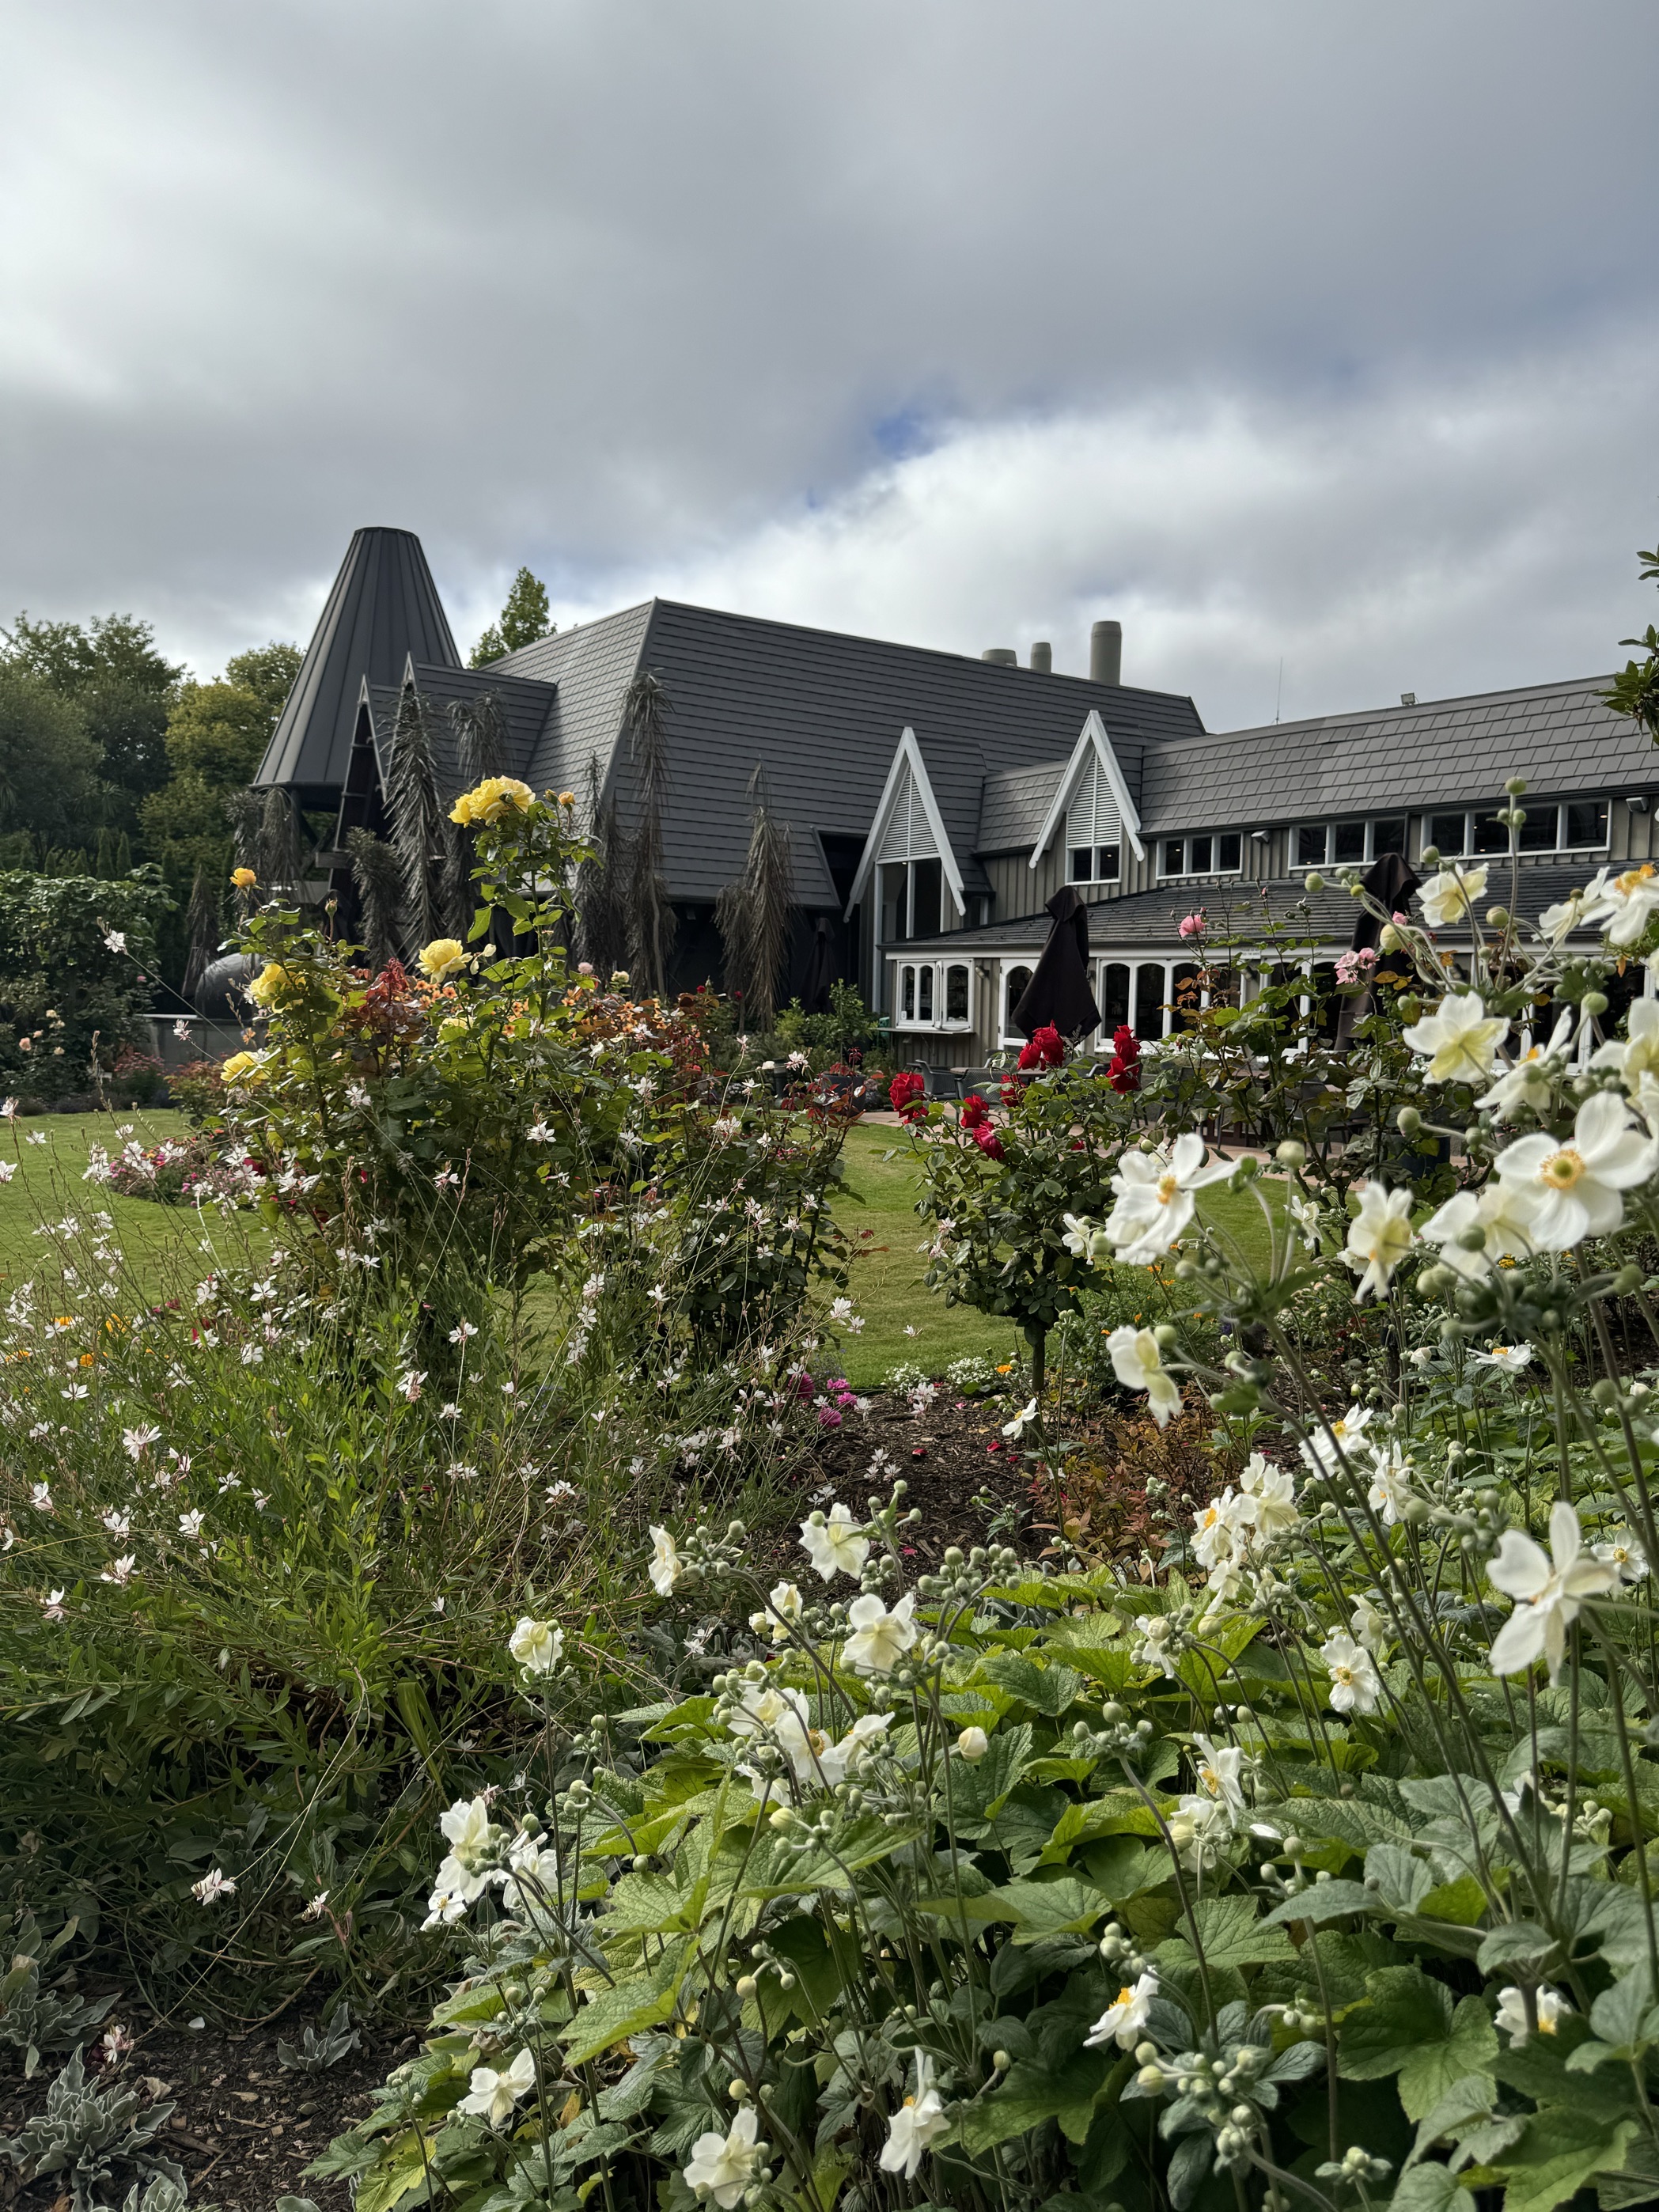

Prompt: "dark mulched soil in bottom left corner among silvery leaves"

[0,2006,416,2212]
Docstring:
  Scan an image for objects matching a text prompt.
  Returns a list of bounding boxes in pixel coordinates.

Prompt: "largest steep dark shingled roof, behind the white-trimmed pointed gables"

[494,600,1203,907]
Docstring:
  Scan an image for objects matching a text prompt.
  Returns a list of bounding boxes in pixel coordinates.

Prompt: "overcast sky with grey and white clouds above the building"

[0,0,1659,728]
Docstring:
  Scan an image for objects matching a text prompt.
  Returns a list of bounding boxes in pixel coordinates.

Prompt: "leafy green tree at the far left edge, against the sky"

[0,615,184,830]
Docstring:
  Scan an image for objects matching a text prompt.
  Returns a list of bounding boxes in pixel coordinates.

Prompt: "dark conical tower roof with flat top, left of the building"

[255,528,460,805]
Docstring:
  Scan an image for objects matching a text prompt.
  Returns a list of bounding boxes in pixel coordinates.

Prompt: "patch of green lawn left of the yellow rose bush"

[0,1106,261,1303]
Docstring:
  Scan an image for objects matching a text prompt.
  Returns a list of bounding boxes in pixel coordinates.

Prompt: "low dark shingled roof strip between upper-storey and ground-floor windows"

[902,861,1619,958]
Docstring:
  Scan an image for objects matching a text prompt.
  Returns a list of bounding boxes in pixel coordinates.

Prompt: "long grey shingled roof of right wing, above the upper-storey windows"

[1131,677,1659,836]
